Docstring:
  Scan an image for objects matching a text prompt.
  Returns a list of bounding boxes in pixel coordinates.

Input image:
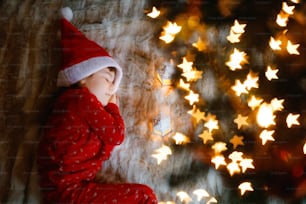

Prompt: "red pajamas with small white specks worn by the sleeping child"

[38,87,157,204]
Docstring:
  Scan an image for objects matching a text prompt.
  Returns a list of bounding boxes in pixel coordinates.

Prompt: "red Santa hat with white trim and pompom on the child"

[57,7,122,92]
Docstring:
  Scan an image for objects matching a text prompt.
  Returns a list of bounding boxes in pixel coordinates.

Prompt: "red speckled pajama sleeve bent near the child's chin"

[78,91,124,145]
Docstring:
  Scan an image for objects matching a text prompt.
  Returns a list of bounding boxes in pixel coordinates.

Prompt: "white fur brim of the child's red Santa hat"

[57,56,122,92]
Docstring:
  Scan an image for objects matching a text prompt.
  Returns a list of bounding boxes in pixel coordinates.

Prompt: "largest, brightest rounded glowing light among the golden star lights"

[256,103,275,128]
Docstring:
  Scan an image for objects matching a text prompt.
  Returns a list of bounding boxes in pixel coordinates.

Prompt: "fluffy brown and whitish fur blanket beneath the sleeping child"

[0,0,226,203]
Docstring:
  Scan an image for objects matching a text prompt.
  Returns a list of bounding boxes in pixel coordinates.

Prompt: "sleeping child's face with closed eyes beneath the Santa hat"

[82,68,115,106]
